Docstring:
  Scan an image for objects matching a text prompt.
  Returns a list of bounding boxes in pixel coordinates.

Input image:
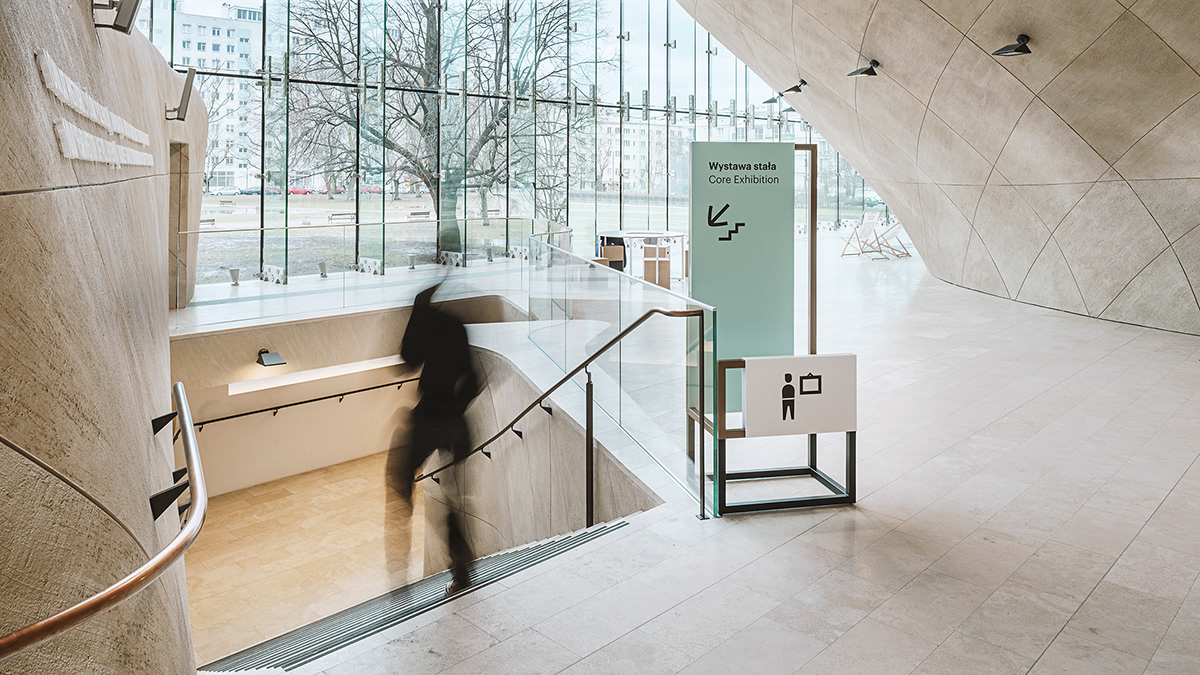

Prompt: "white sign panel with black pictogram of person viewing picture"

[743,354,858,436]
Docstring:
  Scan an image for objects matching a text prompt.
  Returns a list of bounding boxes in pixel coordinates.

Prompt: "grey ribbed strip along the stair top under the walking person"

[200,520,628,673]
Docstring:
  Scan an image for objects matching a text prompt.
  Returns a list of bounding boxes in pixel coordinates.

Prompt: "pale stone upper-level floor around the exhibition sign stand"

[270,242,1200,675]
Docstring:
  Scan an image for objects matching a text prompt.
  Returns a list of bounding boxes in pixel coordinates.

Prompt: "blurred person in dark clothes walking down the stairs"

[388,278,482,596]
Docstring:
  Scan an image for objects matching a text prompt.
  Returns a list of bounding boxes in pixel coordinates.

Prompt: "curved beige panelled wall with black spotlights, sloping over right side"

[680,0,1200,333]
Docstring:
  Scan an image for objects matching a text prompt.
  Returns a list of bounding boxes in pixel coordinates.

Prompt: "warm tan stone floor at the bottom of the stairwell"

[185,453,424,665]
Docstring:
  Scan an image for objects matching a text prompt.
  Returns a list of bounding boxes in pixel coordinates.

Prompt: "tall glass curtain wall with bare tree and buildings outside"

[145,0,883,278]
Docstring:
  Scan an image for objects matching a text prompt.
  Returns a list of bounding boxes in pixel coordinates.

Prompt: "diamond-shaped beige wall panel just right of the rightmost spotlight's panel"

[1040,14,1200,162]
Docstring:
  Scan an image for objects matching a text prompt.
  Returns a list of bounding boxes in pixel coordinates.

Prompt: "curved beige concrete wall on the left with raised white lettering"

[0,0,208,675]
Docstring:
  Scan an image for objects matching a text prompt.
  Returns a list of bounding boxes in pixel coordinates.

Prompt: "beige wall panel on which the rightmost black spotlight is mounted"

[967,0,1124,92]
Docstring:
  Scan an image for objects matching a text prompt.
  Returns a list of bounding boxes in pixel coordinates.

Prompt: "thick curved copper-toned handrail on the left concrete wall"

[0,382,209,662]
